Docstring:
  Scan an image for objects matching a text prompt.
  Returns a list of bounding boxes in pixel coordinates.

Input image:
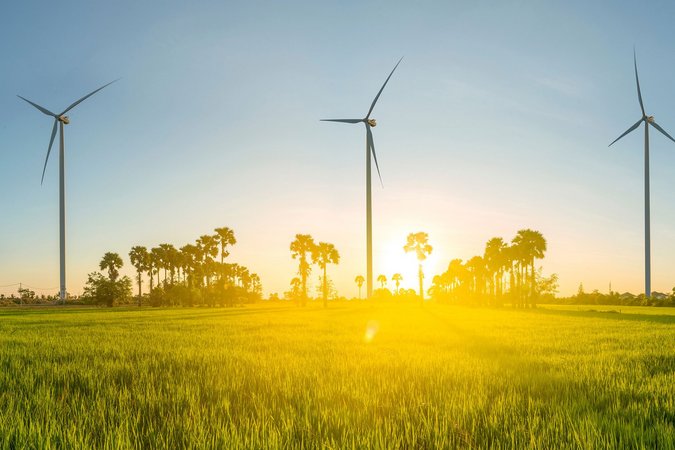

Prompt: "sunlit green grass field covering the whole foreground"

[0,304,675,449]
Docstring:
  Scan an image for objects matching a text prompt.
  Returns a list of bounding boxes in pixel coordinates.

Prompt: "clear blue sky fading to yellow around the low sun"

[0,0,675,297]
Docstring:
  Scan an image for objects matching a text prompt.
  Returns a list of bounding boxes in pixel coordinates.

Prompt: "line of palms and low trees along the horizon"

[0,227,675,308]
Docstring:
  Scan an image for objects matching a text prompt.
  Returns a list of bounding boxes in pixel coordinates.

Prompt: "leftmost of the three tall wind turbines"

[17,80,117,303]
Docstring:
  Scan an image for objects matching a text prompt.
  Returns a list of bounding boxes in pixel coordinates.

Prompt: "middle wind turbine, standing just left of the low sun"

[321,58,403,299]
